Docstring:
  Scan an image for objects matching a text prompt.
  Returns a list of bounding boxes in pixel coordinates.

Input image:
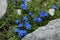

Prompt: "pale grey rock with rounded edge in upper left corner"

[0,0,7,19]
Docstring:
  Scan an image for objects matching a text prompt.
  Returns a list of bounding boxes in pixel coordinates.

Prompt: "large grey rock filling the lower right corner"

[22,19,60,40]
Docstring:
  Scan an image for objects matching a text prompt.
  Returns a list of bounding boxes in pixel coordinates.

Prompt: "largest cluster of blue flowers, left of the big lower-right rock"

[14,16,32,38]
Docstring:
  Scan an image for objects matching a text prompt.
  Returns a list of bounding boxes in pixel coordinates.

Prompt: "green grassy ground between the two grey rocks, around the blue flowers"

[0,0,60,40]
